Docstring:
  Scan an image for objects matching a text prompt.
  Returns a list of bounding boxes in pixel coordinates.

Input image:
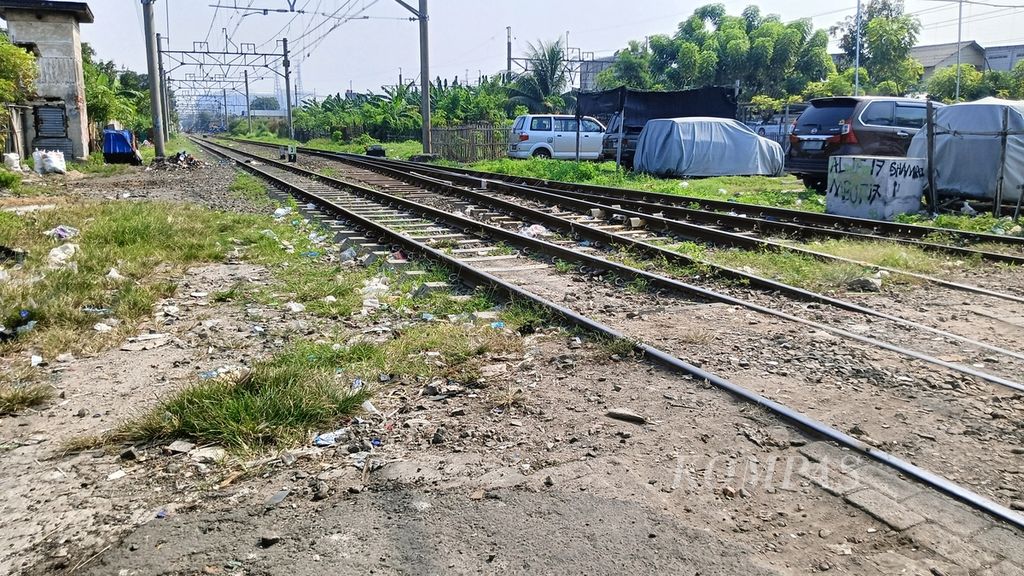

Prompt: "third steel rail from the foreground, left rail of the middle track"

[305,150,1024,366]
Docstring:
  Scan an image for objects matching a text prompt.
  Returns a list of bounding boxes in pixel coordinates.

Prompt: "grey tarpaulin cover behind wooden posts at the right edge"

[907,98,1024,202]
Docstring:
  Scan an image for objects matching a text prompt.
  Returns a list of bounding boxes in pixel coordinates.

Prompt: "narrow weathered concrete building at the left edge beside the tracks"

[0,0,93,158]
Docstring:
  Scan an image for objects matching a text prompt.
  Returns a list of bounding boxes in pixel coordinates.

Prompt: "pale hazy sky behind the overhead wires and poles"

[8,0,1024,95]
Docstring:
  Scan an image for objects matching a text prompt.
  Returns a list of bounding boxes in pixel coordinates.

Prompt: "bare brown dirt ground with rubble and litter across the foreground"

[0,154,1024,576]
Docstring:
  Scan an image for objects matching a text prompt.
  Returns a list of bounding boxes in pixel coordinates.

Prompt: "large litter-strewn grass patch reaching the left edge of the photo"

[0,202,348,358]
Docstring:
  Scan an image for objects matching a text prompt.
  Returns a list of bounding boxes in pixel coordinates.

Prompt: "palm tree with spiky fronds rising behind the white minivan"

[509,39,568,113]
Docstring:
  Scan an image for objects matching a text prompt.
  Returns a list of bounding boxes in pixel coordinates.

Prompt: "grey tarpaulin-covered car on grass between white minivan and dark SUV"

[633,117,785,176]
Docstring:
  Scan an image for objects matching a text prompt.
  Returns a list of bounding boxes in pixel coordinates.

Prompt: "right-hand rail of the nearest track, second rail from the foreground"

[197,138,1024,392]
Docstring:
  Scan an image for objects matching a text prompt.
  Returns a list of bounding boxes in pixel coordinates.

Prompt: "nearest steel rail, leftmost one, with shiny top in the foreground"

[196,134,1024,530]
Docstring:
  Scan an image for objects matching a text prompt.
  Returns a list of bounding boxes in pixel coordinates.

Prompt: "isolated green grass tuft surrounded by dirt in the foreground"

[114,344,370,452]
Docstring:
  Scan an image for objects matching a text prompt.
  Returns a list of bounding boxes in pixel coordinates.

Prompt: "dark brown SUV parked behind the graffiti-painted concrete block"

[785,96,939,192]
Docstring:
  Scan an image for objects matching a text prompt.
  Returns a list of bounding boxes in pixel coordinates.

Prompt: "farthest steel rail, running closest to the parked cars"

[229,138,1024,247]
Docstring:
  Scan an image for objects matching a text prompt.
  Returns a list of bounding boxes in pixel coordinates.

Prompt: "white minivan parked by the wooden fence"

[509,114,604,160]
